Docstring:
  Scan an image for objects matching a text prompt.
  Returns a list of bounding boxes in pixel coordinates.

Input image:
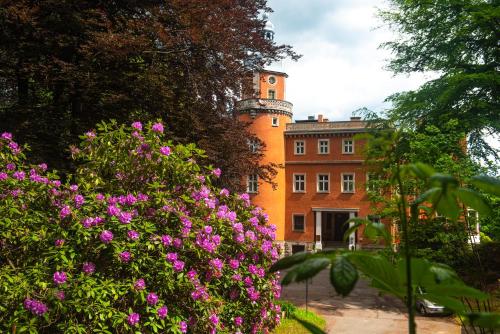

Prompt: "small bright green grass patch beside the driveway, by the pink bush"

[274,308,326,334]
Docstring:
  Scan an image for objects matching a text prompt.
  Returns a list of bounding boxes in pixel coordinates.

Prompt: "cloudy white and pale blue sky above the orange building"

[268,0,436,120]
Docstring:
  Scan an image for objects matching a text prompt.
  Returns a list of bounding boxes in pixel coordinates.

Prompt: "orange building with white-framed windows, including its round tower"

[236,70,382,253]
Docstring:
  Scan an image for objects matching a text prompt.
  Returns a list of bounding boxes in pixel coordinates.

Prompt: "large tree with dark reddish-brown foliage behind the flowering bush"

[0,0,298,187]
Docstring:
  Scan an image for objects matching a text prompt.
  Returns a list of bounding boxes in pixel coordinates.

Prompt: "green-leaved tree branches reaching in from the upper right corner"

[380,0,500,166]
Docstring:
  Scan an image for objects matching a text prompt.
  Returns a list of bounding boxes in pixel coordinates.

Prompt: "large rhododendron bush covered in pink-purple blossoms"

[0,122,280,333]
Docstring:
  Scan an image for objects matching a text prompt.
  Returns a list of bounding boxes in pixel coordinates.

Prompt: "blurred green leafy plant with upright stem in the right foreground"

[271,163,500,333]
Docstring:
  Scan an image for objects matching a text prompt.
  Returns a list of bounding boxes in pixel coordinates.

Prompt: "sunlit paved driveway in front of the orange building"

[282,270,460,334]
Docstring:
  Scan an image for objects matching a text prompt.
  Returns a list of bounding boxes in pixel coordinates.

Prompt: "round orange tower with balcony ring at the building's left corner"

[236,17,292,242]
